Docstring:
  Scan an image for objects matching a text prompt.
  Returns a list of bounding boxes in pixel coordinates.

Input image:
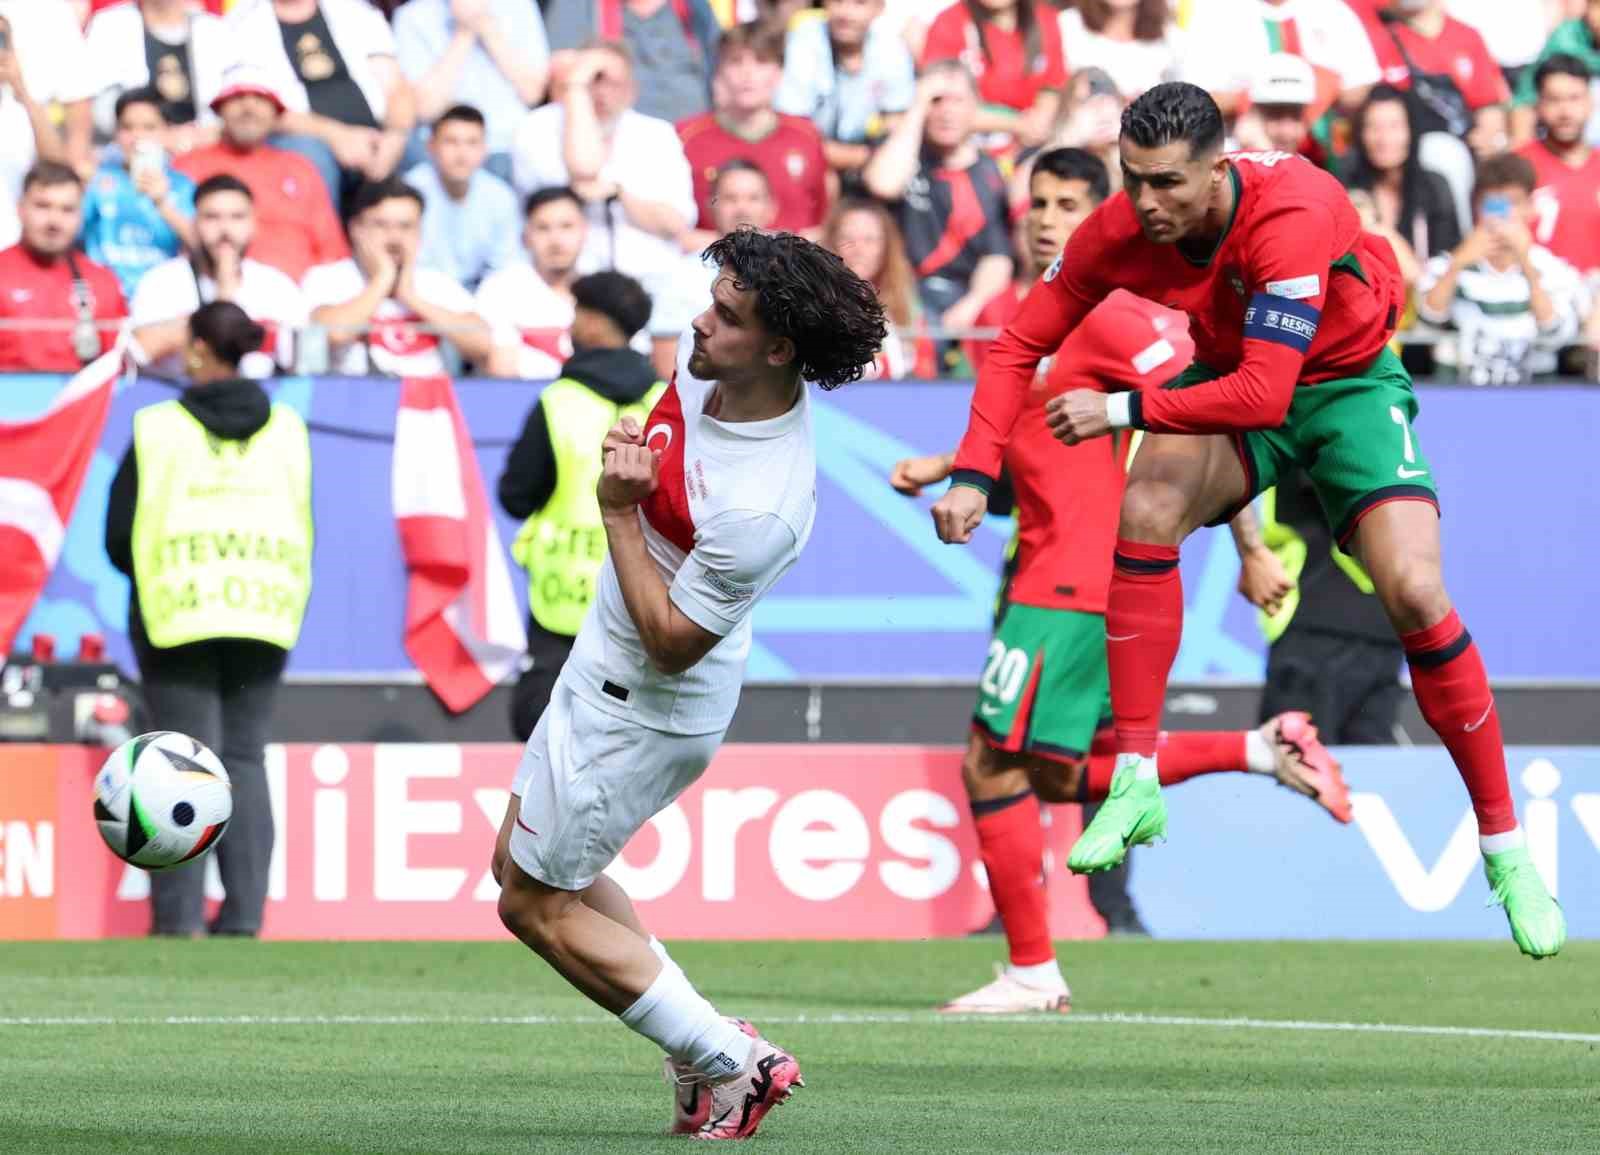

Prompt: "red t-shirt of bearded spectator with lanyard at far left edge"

[0,245,128,373]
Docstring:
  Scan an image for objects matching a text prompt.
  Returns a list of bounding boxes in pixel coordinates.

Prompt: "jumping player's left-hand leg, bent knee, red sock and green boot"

[1067,435,1248,873]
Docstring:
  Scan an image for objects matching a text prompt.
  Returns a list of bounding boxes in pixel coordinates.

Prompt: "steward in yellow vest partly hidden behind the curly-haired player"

[499,272,666,741]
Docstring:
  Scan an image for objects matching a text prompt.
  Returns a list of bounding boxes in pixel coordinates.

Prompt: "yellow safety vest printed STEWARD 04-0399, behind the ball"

[133,402,312,649]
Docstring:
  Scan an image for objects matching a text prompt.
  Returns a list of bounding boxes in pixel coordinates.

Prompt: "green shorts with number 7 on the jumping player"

[1168,349,1438,544]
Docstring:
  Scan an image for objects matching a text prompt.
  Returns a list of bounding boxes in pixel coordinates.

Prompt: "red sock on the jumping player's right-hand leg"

[1400,609,1517,835]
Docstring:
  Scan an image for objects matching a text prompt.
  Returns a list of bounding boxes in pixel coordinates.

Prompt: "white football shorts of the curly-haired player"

[510,678,722,891]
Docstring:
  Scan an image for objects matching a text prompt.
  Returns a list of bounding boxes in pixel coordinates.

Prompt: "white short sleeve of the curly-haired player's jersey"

[667,509,800,637]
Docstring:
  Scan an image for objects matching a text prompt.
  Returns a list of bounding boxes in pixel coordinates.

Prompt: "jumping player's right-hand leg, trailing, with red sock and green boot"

[1355,501,1566,958]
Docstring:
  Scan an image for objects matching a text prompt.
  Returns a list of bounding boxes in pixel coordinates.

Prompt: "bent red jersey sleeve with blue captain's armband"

[1130,200,1334,434]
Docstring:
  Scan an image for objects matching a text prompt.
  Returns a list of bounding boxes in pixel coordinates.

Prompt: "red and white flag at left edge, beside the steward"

[0,346,123,657]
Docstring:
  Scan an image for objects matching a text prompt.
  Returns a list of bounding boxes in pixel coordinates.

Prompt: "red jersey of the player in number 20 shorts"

[1005,290,1194,614]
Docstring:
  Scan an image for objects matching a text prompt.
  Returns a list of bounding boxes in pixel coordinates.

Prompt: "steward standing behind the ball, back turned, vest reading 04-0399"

[106,301,312,936]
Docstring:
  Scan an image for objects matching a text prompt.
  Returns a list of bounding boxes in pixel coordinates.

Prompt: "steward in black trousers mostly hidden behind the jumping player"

[1259,470,1405,745]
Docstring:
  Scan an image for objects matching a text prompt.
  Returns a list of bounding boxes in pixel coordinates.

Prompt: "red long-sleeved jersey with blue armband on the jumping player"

[955,152,1405,478]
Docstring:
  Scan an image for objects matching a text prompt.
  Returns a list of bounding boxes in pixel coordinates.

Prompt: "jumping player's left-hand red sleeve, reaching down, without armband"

[950,216,1106,493]
